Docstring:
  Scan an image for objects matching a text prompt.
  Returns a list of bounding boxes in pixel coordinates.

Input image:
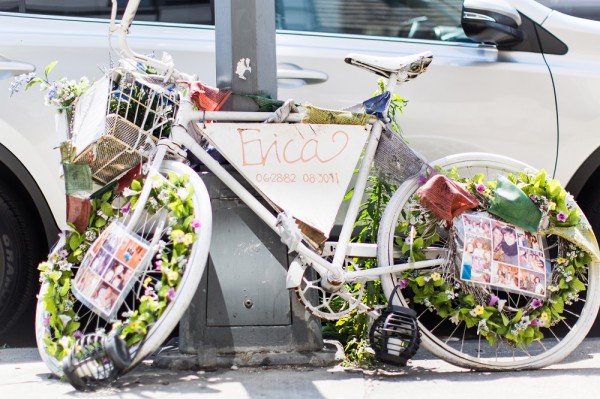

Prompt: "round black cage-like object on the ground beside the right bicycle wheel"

[369,286,421,366]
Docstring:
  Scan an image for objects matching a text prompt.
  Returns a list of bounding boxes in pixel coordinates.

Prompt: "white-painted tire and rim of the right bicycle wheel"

[378,153,600,371]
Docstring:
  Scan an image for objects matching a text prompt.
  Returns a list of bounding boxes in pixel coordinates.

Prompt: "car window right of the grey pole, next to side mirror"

[276,0,466,41]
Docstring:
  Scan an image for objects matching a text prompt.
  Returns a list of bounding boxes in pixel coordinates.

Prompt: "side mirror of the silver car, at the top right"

[461,0,525,47]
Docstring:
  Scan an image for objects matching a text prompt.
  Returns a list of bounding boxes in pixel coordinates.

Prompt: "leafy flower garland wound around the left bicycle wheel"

[38,174,200,360]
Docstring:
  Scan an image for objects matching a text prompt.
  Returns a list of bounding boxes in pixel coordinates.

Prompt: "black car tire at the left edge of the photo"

[0,186,43,335]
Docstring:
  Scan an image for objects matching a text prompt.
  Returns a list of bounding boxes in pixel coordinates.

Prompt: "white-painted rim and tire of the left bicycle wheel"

[36,161,212,376]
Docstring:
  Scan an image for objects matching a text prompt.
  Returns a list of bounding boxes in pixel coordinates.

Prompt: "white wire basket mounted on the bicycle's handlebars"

[73,67,178,185]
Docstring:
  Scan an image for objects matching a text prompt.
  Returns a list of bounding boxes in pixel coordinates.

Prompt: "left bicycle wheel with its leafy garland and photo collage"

[36,161,212,376]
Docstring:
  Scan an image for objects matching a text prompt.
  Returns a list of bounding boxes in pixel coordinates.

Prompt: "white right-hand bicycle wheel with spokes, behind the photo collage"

[378,153,600,370]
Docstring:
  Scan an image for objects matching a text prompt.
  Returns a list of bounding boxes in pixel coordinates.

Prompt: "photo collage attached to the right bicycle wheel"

[461,213,550,297]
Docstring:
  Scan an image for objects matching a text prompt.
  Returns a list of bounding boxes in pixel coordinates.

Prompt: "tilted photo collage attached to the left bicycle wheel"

[73,223,148,320]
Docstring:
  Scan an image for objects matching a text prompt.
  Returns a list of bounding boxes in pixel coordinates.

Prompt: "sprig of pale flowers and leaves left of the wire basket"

[8,61,90,113]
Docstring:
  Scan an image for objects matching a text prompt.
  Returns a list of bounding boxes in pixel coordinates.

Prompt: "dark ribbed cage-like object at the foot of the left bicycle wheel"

[63,333,131,391]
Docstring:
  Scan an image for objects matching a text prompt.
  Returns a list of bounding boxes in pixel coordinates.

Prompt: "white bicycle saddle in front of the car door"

[344,51,433,83]
